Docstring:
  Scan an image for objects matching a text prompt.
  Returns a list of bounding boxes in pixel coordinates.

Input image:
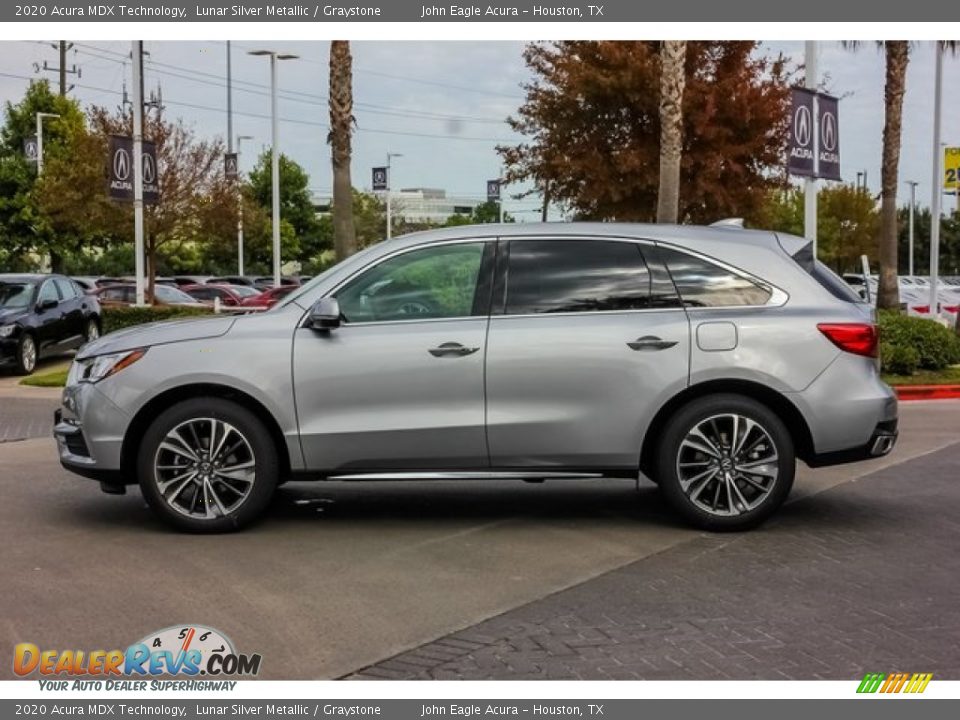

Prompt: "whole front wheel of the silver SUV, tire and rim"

[137,398,279,533]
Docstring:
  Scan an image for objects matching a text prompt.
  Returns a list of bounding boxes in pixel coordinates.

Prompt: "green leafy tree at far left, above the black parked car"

[0,80,84,271]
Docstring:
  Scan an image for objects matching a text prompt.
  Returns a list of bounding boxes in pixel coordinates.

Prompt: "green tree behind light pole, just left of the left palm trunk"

[248,149,324,261]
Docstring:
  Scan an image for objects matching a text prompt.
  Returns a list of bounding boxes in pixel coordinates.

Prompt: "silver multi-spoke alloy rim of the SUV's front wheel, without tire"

[153,417,256,520]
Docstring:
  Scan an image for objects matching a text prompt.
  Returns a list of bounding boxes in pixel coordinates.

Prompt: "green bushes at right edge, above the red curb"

[880,311,960,375]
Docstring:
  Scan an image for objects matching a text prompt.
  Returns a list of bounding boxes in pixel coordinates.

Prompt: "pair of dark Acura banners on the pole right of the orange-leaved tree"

[787,87,841,180]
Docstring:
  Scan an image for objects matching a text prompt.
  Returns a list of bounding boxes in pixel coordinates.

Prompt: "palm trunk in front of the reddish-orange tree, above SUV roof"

[657,40,687,223]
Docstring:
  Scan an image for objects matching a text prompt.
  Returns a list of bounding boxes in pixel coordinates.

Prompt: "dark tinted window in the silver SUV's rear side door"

[505,240,651,315]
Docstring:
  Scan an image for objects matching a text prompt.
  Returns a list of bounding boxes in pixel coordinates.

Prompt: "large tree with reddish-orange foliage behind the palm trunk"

[497,40,790,222]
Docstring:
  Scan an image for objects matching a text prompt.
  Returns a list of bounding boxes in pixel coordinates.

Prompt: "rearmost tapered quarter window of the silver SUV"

[660,247,773,307]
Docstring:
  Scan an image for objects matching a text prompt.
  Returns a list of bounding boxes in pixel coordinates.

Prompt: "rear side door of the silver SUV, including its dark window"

[487,238,690,472]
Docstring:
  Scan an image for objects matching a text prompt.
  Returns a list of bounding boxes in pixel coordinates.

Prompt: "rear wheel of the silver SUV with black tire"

[654,394,796,531]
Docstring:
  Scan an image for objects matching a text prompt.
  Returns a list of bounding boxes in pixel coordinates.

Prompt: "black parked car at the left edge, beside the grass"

[0,274,100,375]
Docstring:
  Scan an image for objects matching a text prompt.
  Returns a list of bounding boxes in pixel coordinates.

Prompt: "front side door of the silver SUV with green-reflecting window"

[293,241,496,471]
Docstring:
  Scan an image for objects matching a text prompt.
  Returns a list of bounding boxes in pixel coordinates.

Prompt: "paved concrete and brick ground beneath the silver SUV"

[0,388,960,679]
